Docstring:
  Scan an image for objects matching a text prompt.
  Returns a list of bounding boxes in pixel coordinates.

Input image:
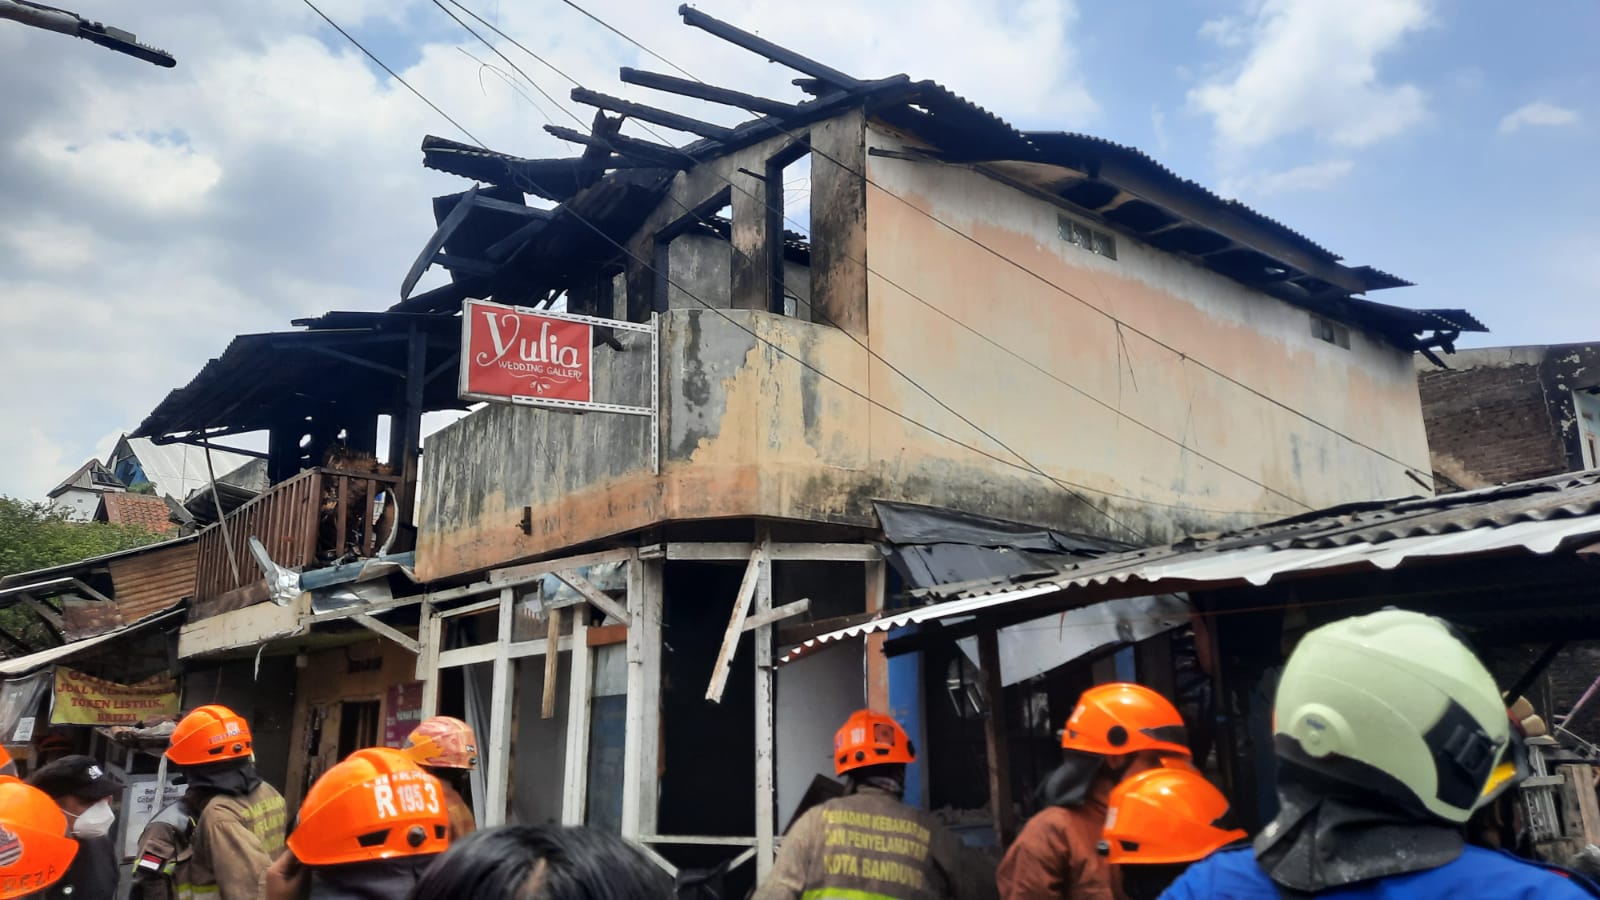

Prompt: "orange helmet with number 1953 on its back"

[288,746,450,866]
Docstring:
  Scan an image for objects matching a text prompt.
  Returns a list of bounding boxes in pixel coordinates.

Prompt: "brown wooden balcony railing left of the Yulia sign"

[195,469,400,604]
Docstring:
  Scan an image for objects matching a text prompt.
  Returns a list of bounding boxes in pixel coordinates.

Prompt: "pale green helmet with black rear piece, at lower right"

[1274,609,1510,823]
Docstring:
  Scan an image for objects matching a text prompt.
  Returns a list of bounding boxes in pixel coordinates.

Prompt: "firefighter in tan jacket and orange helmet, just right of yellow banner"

[166,705,288,900]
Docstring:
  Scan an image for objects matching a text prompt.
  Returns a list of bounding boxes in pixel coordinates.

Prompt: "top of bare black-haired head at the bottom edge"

[408,825,672,900]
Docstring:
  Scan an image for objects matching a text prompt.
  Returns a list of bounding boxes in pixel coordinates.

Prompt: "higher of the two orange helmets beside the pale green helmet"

[1061,682,1190,759]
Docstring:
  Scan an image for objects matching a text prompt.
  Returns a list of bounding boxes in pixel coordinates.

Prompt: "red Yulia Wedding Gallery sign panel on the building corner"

[459,299,594,404]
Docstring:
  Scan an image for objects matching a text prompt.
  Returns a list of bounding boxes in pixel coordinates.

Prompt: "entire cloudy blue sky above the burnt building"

[0,0,1600,496]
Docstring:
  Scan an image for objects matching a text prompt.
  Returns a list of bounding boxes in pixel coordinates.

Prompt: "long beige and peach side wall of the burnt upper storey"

[867,121,1429,538]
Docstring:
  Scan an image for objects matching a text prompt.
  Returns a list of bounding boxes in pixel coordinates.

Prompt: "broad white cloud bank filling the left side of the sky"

[0,0,1096,496]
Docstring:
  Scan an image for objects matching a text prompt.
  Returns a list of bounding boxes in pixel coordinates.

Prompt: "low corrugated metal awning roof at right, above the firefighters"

[779,471,1600,663]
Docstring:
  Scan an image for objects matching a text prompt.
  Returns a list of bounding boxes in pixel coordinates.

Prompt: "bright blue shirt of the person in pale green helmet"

[1162,847,1590,900]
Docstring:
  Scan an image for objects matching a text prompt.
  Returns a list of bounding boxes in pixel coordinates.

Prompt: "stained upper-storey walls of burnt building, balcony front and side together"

[418,115,1430,580]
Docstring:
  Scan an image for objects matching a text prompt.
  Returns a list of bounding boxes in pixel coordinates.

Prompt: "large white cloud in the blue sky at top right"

[1189,0,1430,151]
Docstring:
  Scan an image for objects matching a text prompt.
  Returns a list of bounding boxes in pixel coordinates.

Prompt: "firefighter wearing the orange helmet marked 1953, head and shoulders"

[261,746,450,900]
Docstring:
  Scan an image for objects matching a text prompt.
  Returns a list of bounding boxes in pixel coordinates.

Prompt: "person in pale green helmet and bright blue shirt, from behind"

[1166,609,1589,900]
